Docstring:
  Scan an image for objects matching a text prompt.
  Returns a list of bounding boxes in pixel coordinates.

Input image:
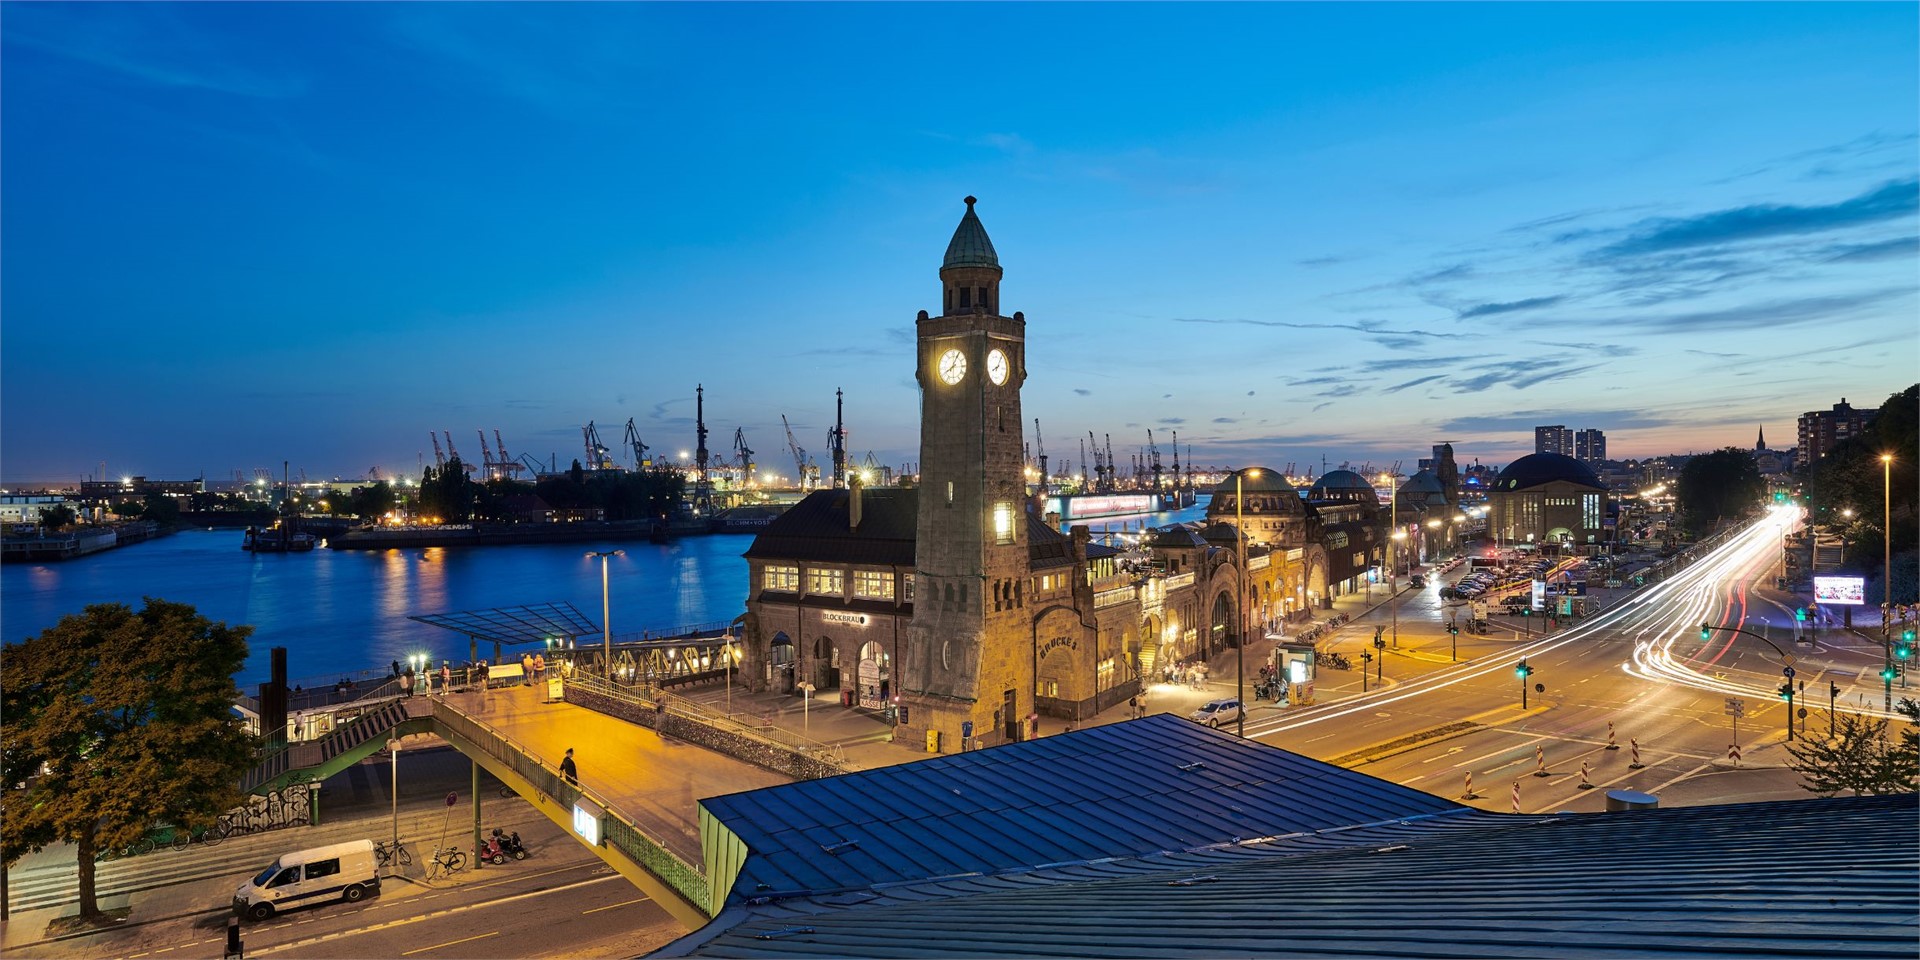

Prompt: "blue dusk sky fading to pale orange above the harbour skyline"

[0,4,1920,484]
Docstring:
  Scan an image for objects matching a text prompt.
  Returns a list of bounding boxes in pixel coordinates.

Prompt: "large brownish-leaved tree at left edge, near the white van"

[0,597,255,920]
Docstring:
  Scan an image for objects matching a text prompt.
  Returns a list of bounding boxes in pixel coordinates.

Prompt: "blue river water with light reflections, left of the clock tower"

[0,499,1206,689]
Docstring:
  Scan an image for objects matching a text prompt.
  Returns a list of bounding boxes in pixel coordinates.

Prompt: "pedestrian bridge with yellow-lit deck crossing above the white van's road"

[242,684,794,929]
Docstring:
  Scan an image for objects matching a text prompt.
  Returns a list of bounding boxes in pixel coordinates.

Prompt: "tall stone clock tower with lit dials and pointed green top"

[900,198,1035,751]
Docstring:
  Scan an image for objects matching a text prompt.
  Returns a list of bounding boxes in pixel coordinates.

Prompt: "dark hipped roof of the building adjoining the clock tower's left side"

[745,488,920,566]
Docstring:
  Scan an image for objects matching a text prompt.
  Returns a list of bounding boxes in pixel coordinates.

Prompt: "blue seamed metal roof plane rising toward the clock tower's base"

[701,714,1451,902]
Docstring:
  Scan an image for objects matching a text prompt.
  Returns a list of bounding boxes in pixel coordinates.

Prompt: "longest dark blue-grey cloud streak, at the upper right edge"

[1596,179,1920,257]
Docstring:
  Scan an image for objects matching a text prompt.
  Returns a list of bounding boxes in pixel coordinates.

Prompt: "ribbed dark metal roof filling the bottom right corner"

[664,791,1920,958]
